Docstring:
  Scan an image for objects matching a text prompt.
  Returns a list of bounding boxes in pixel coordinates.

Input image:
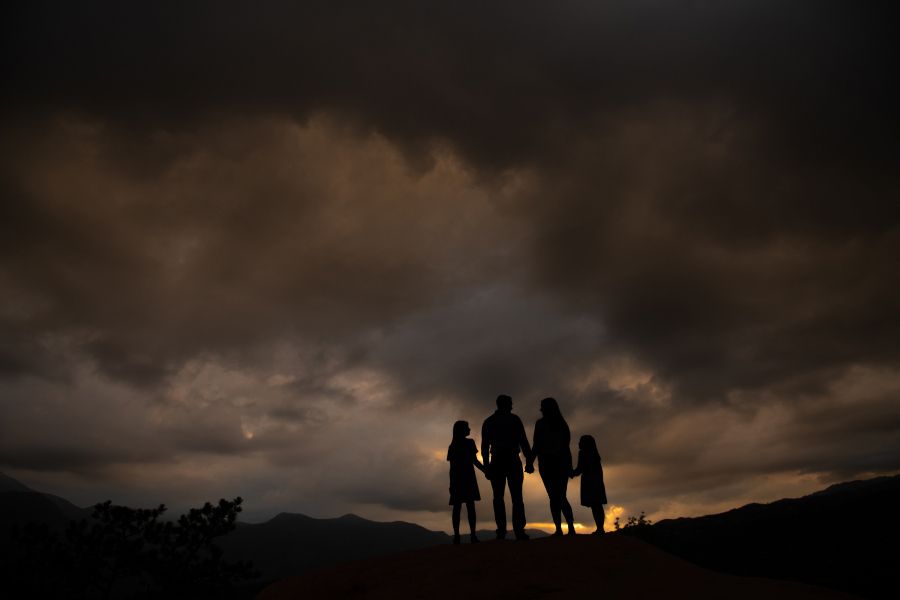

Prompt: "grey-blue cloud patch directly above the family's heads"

[368,284,604,408]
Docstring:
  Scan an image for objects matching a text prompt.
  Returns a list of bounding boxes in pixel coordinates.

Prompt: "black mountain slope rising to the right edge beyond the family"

[622,476,900,598]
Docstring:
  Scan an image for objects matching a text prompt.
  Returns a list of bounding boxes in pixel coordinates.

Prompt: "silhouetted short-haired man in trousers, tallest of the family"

[481,394,531,540]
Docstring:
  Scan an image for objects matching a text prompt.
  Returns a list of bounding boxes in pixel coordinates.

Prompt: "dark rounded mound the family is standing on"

[258,534,854,600]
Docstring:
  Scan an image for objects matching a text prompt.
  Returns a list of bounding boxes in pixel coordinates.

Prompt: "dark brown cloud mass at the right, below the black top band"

[520,114,900,400]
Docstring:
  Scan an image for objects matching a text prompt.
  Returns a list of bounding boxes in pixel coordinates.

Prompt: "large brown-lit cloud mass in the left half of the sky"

[0,115,503,385]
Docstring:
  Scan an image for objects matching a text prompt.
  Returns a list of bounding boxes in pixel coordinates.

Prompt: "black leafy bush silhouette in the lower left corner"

[13,498,255,598]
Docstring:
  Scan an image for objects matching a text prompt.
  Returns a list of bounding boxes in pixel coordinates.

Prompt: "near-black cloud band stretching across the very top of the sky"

[4,1,897,166]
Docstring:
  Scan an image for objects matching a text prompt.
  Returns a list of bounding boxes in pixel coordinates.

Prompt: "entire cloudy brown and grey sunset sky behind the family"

[0,0,900,530]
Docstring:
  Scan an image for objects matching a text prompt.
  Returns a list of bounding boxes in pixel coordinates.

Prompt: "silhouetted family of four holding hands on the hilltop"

[447,394,606,544]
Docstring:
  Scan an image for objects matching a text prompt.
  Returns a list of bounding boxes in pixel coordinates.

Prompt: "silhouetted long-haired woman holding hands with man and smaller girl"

[529,398,575,535]
